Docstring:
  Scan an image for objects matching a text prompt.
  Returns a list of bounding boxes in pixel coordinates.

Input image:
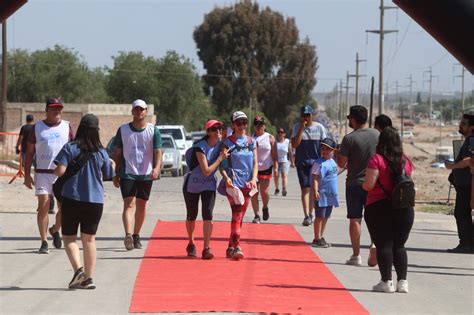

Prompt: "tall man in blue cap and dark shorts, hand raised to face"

[291,105,327,226]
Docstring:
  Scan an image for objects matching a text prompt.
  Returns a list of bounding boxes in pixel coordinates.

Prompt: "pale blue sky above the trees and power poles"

[8,0,474,94]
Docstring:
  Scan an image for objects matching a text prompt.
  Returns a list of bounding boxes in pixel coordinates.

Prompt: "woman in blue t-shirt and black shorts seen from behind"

[54,114,114,289]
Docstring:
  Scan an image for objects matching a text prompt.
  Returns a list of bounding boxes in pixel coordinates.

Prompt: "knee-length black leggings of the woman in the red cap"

[183,190,216,221]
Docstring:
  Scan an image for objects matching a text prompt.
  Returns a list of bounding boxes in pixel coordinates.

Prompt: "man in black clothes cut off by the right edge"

[445,114,474,253]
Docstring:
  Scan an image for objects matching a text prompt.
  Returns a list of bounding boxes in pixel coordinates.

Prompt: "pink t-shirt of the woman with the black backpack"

[366,154,413,205]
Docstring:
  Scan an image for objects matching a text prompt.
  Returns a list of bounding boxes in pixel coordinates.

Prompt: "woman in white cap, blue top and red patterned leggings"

[220,111,258,260]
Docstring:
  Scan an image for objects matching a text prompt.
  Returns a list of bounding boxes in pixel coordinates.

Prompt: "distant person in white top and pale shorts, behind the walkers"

[273,128,295,197]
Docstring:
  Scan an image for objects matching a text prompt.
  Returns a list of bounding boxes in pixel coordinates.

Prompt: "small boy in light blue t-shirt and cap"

[311,138,339,248]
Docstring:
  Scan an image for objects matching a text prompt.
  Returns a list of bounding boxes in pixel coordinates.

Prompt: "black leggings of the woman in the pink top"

[364,199,415,281]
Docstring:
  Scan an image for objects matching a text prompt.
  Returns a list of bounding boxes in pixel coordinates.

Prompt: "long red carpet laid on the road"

[130,221,367,314]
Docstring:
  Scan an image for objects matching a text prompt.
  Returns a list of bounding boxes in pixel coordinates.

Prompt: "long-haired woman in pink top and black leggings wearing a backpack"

[362,127,414,293]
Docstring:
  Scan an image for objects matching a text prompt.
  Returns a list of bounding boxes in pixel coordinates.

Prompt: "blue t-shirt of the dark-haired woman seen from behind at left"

[54,142,115,203]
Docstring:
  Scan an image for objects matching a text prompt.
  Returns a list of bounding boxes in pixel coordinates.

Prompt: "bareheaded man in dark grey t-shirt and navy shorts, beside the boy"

[336,105,379,266]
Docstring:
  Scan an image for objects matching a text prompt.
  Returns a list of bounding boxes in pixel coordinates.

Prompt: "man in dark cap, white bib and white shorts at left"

[24,97,74,254]
